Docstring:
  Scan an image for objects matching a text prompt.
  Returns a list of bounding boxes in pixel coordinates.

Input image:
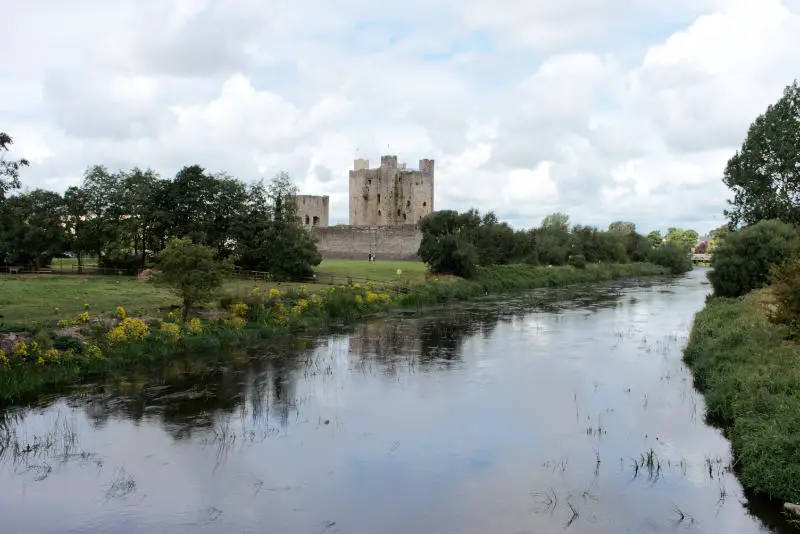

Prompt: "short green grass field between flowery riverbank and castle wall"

[0,258,432,331]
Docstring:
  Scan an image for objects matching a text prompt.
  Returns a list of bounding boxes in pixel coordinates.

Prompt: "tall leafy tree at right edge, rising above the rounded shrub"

[723,80,800,229]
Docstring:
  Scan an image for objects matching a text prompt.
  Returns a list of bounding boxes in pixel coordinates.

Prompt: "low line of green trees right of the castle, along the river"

[419,209,698,278]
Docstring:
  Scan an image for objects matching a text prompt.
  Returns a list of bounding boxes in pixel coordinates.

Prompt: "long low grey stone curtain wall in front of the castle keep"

[312,224,422,261]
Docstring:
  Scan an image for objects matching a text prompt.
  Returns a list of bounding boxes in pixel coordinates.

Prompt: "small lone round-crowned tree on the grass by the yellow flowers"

[151,237,233,321]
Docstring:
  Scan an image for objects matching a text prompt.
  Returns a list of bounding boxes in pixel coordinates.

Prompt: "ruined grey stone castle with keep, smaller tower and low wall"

[296,156,434,260]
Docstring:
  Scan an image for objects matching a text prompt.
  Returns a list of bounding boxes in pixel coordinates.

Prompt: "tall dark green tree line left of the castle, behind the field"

[0,134,322,278]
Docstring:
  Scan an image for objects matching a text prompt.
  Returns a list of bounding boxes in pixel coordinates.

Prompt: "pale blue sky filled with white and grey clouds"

[0,0,800,233]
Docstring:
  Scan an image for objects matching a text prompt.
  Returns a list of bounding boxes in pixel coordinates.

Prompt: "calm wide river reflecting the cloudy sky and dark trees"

[0,269,787,534]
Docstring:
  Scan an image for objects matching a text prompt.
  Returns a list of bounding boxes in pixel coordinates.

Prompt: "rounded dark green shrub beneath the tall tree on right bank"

[708,221,797,297]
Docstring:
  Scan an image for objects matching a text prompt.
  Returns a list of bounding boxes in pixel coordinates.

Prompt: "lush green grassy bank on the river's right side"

[684,292,800,502]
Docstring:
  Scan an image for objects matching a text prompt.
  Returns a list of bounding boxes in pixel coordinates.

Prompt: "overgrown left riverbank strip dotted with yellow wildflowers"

[0,263,668,401]
